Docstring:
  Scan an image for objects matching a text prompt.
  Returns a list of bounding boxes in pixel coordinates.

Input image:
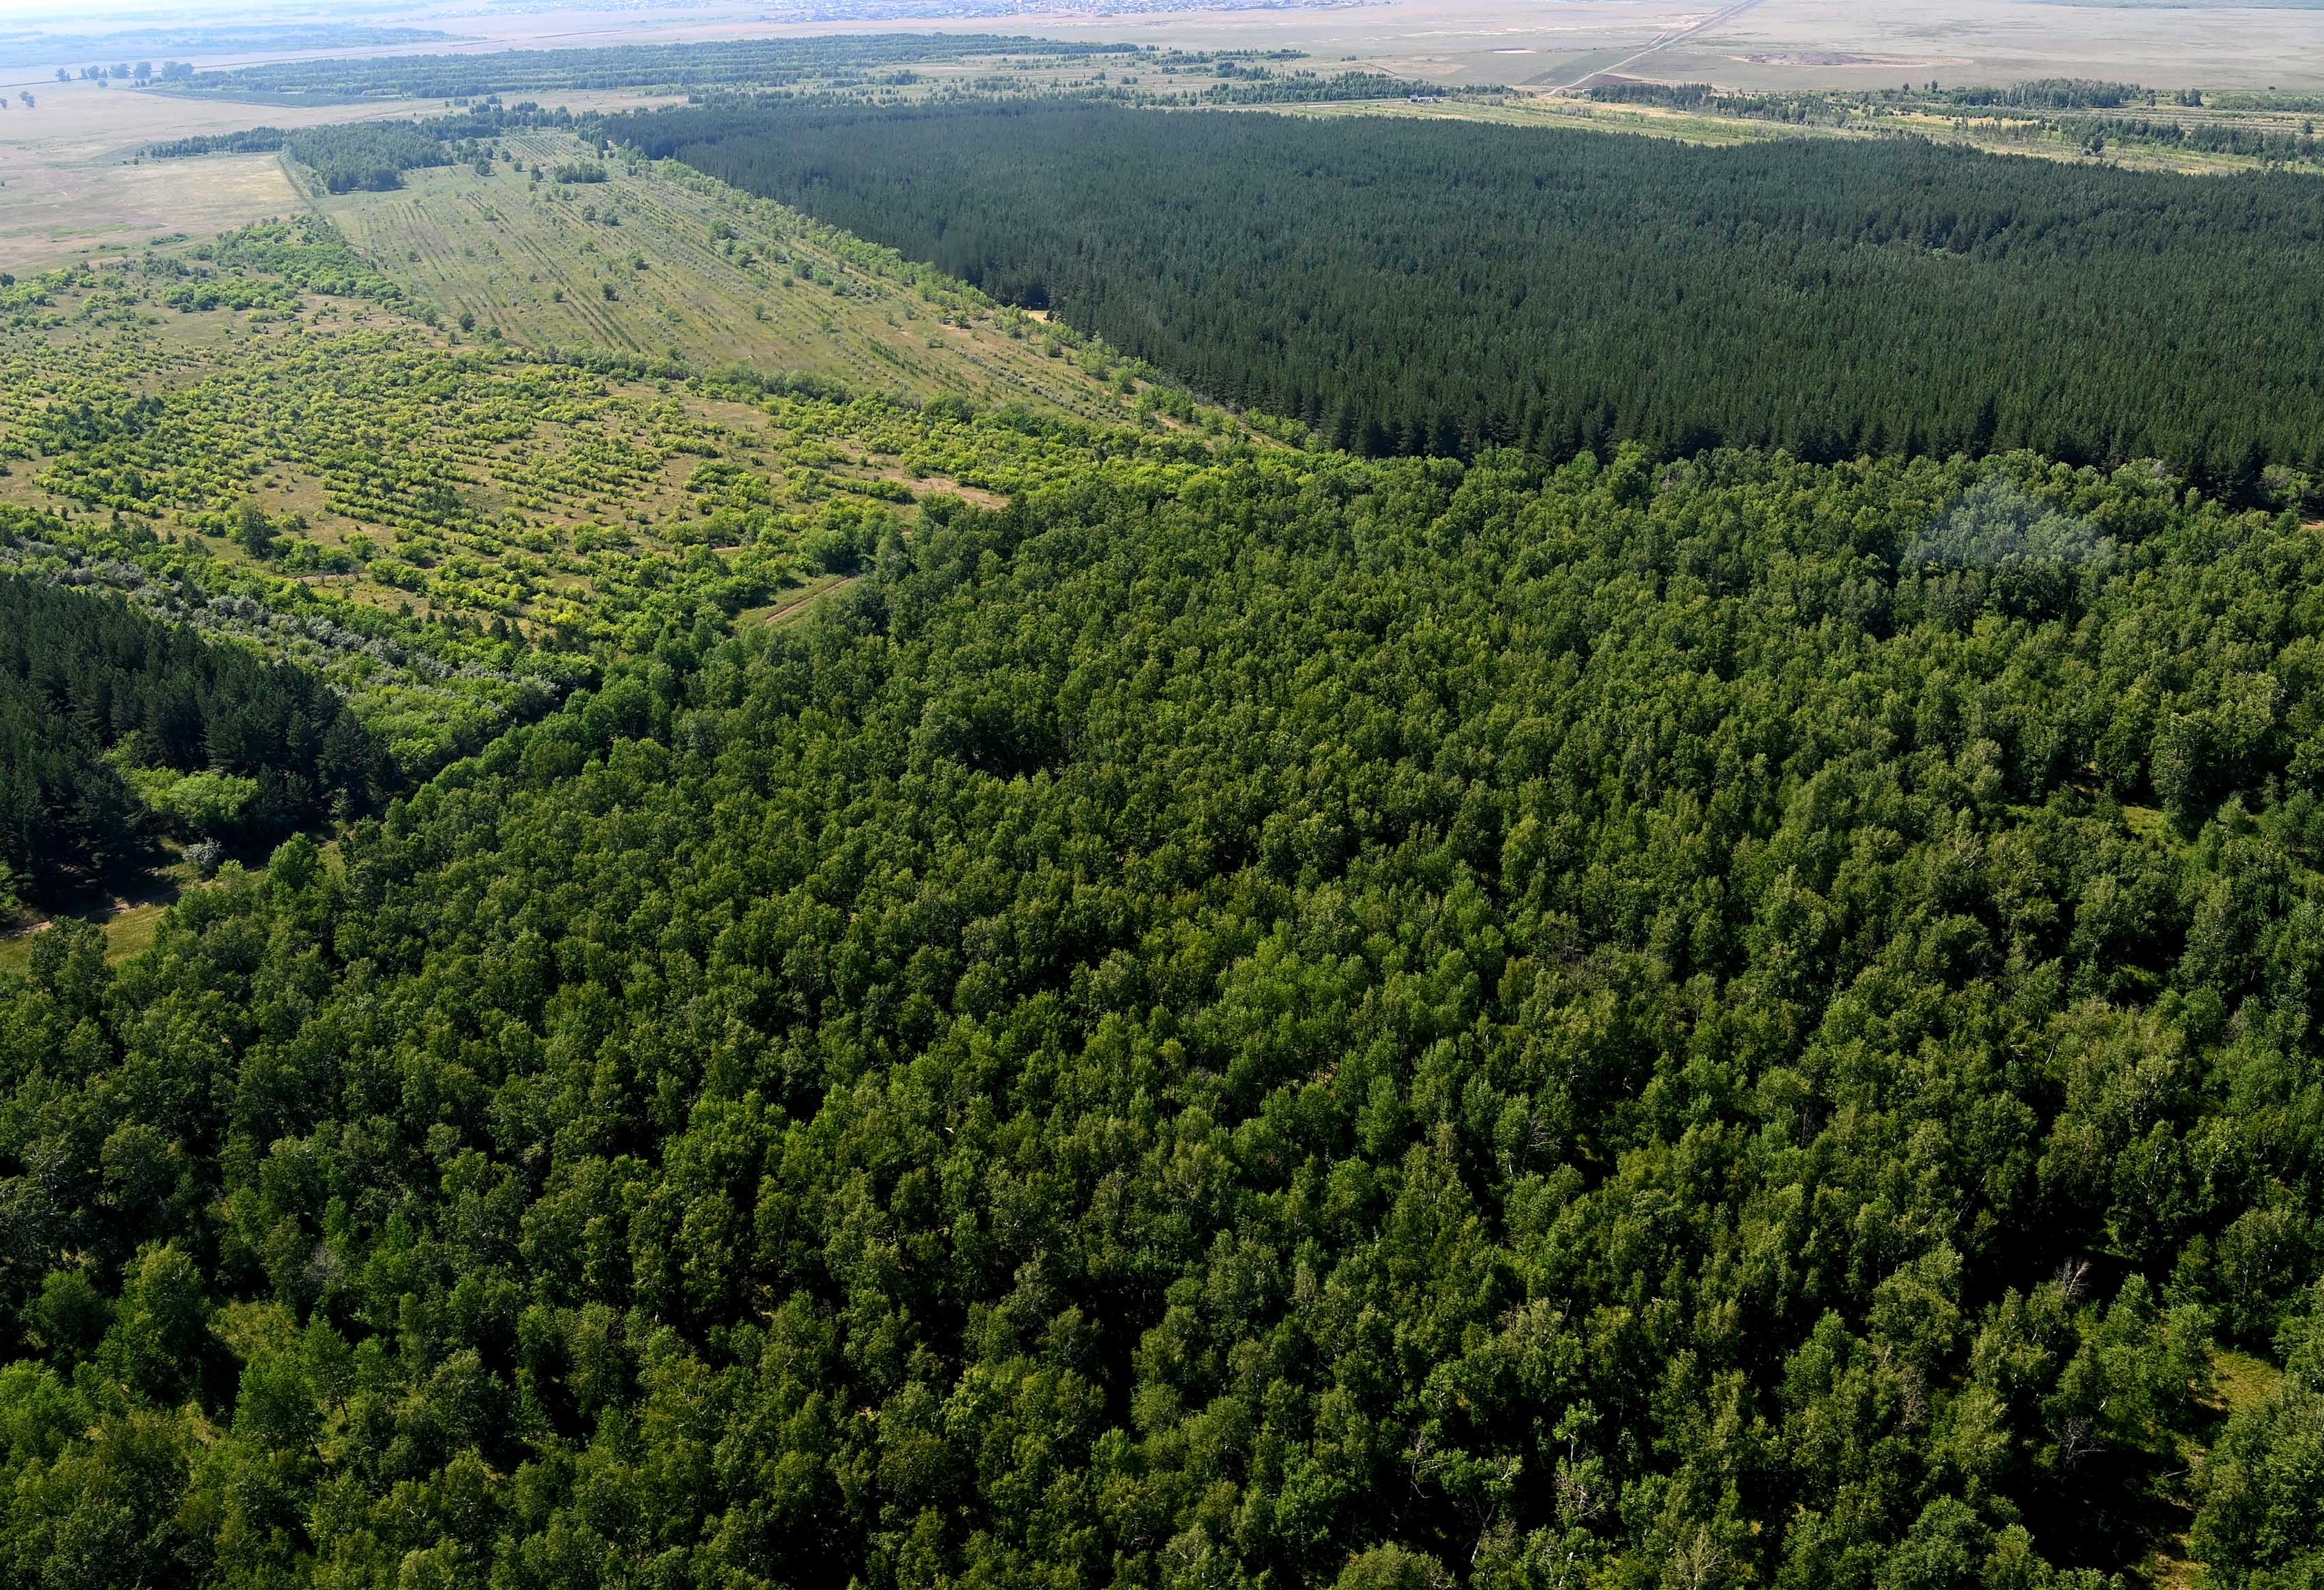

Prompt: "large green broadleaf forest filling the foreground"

[13,451,2324,1590]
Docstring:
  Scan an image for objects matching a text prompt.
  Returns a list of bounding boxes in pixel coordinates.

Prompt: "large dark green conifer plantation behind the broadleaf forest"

[609,100,2324,500]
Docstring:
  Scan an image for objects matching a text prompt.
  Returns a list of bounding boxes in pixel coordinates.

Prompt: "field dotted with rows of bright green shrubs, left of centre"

[0,223,1234,769]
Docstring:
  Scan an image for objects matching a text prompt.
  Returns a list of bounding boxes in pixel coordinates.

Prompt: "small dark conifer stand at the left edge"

[0,572,390,899]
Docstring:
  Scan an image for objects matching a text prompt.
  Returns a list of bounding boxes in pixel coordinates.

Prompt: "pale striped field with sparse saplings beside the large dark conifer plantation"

[323,133,1157,421]
